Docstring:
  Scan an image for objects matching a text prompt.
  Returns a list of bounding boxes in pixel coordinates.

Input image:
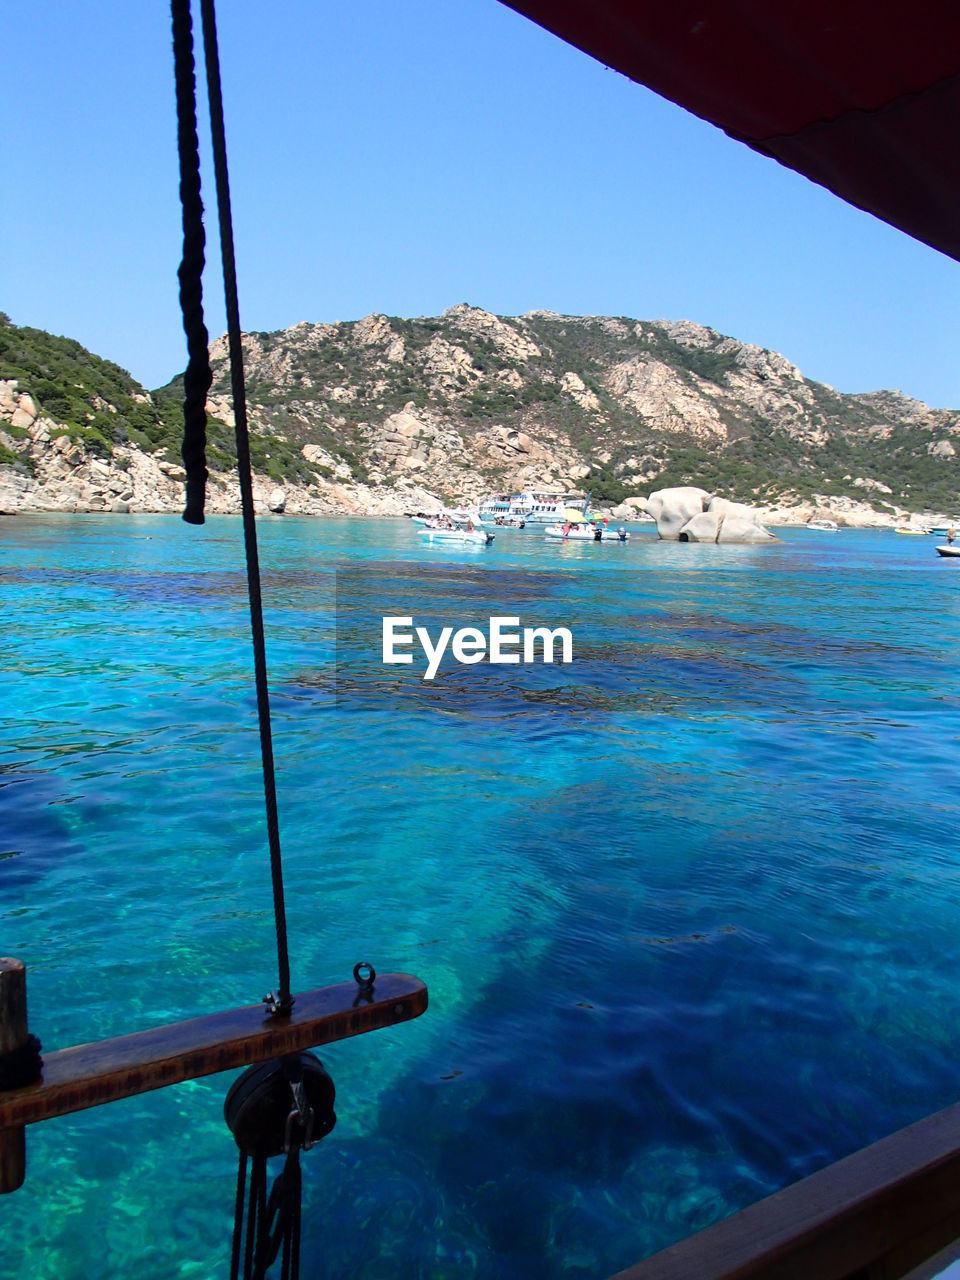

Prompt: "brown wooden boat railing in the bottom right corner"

[613,1103,960,1280]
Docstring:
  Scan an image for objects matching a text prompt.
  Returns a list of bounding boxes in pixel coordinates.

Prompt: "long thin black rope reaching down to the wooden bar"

[200,0,293,1015]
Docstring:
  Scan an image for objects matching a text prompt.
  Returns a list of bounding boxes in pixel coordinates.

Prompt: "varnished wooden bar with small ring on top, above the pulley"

[0,961,426,1131]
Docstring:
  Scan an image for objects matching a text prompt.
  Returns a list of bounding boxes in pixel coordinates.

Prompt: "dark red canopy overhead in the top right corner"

[503,0,960,260]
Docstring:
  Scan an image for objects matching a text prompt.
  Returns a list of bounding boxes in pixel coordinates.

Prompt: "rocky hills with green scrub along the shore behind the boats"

[0,305,960,521]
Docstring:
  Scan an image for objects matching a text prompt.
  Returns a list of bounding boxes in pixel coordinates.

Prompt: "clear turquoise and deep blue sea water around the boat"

[0,516,960,1280]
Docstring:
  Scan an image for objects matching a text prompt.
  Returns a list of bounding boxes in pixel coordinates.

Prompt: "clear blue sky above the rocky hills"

[7,0,960,407]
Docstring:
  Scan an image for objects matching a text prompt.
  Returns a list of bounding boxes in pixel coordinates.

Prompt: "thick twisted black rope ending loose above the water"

[172,0,212,525]
